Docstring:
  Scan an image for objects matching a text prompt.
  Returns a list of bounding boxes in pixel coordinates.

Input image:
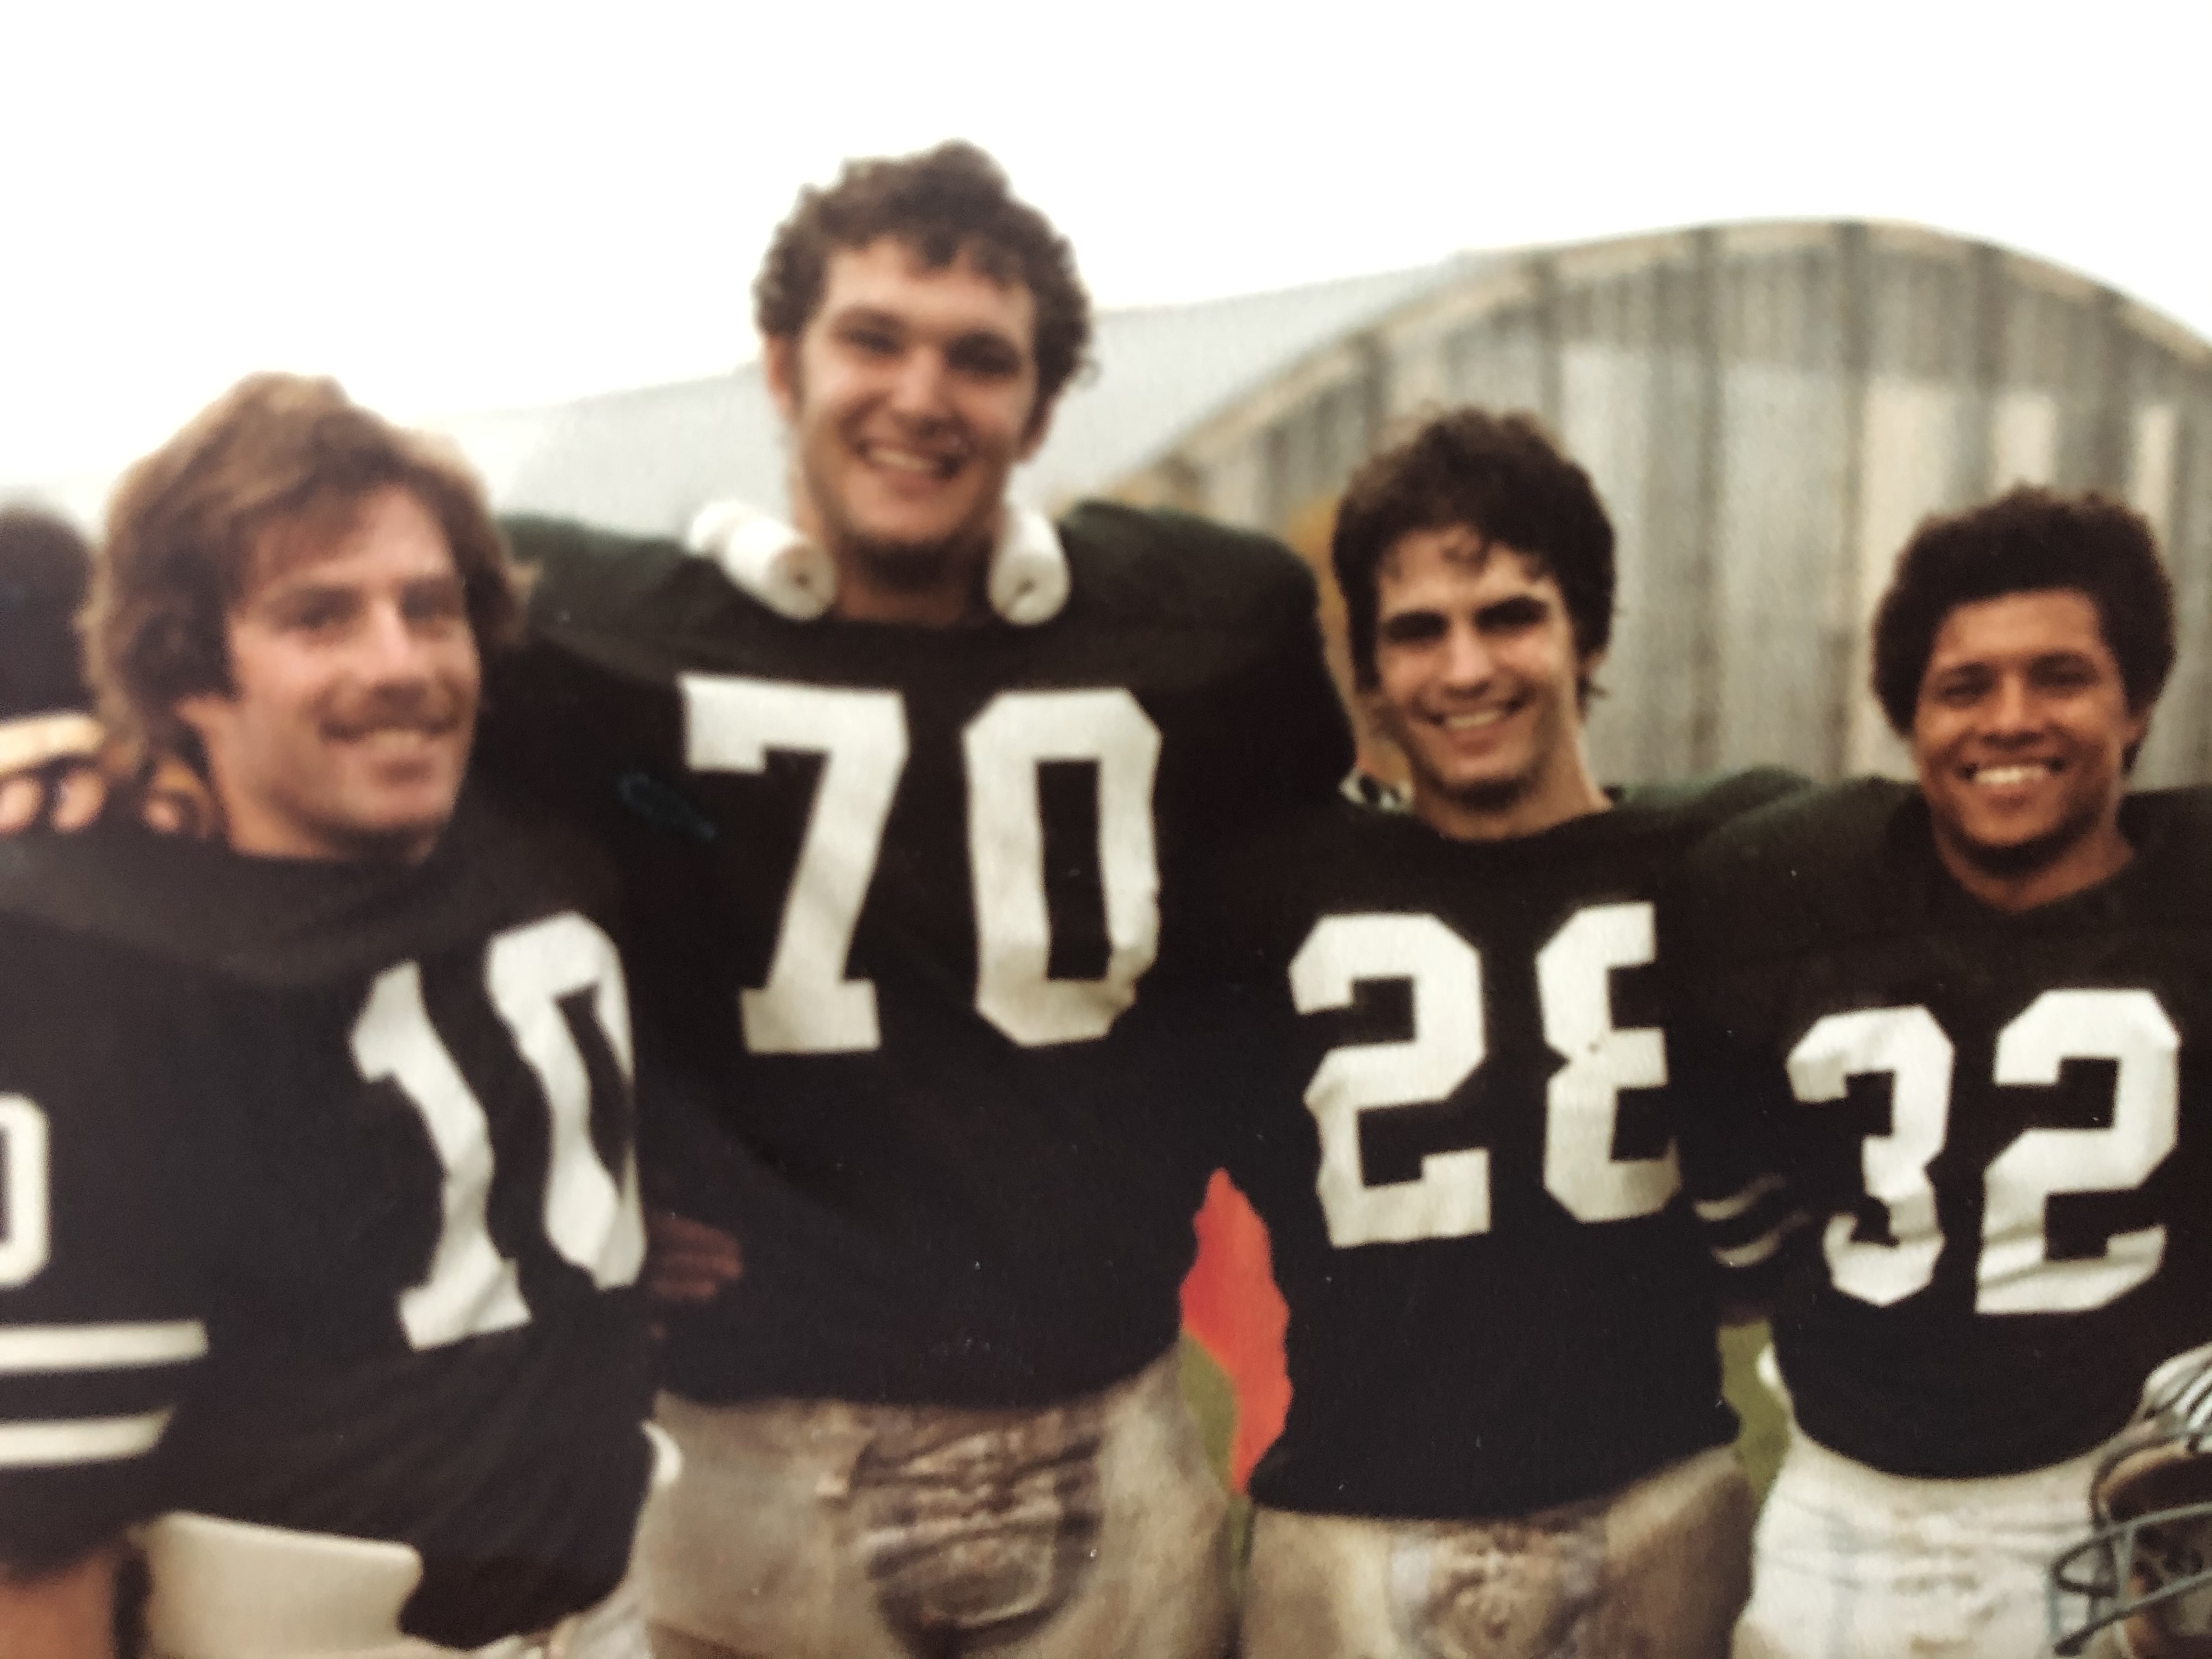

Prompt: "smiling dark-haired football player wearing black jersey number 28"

[1221,409,1796,1659]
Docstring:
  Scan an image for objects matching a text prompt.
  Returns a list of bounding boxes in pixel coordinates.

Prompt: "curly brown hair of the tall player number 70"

[752,139,1091,420]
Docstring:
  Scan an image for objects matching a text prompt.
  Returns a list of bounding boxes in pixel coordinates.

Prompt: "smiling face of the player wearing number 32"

[1911,589,2150,909]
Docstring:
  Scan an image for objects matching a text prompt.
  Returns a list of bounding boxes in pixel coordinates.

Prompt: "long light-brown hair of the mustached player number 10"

[77,374,522,763]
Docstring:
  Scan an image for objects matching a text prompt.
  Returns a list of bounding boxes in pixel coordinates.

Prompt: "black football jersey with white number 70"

[480,506,1350,1404]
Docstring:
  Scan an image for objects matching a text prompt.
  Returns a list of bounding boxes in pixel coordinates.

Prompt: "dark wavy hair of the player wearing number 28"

[1329,409,1612,701]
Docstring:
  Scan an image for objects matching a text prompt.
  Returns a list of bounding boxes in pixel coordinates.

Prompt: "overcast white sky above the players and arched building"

[0,0,2212,491]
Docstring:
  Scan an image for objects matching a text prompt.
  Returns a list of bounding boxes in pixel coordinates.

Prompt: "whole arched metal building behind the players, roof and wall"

[21,221,2212,783]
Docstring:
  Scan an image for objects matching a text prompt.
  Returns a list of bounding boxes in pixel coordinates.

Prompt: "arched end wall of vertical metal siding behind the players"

[1159,223,2212,783]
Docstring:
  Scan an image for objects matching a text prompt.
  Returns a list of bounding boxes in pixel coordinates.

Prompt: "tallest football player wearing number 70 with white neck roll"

[484,144,1350,1659]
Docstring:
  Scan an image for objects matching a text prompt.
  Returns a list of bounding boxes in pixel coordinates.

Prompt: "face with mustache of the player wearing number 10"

[177,487,480,860]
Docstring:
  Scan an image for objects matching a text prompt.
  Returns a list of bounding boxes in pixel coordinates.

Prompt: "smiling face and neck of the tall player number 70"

[765,236,1044,622]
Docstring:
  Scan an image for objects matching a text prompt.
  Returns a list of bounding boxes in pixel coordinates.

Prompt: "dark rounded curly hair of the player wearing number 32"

[1874,487,2174,761]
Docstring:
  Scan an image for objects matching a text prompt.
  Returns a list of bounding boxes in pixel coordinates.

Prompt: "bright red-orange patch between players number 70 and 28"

[1183,1170,1290,1491]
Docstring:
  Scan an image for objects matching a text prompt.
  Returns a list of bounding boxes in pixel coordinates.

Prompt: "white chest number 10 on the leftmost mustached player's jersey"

[354,913,646,1350]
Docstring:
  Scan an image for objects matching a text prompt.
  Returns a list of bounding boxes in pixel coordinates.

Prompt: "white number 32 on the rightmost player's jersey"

[1790,991,2181,1314]
